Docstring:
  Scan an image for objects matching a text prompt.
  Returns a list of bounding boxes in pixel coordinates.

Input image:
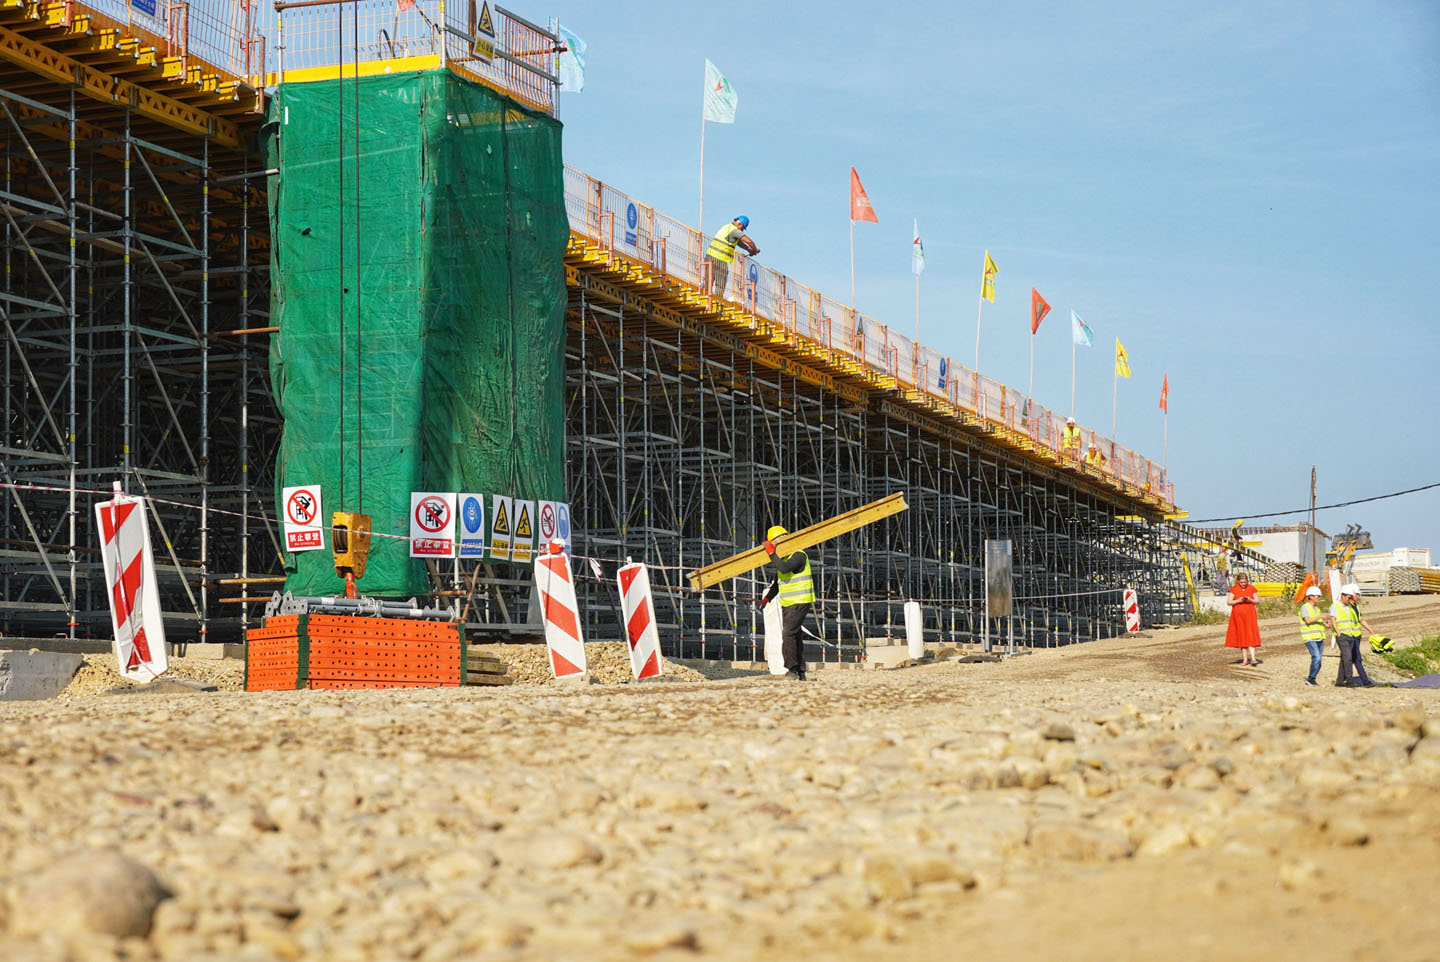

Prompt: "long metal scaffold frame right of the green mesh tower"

[566,271,1189,660]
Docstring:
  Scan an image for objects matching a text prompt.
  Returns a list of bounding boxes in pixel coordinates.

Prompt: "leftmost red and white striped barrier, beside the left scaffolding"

[95,482,170,681]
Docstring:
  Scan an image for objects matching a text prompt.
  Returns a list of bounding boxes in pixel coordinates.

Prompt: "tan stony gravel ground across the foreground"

[11,599,1440,962]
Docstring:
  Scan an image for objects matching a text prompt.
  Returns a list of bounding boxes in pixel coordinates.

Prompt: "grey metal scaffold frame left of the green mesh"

[0,84,278,641]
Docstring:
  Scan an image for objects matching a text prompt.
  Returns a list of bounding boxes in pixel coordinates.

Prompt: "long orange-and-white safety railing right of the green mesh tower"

[564,166,1175,507]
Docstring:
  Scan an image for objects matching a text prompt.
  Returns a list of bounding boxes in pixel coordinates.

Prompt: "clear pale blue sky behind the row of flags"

[544,0,1440,562]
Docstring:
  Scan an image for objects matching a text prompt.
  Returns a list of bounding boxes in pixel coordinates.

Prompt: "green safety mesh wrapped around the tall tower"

[265,69,569,596]
